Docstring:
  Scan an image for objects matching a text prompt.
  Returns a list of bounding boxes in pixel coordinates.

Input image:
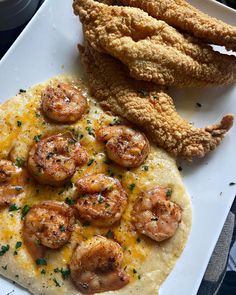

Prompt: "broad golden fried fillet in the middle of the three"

[74,0,236,87]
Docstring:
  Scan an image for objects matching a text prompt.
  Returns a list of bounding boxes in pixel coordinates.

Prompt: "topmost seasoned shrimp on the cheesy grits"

[41,83,87,123]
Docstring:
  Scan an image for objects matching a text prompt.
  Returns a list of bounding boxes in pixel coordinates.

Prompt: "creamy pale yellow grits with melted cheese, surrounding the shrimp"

[0,77,191,295]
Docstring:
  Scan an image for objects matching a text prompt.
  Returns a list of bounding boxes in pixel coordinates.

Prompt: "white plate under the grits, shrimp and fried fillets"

[0,0,236,295]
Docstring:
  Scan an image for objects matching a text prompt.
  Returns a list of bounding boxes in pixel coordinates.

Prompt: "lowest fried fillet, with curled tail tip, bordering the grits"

[79,46,233,160]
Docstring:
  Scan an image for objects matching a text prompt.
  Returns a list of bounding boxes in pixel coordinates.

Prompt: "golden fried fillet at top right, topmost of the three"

[121,0,236,51]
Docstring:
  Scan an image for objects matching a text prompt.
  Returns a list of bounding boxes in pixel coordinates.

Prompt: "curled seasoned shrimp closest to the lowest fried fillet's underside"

[97,126,149,168]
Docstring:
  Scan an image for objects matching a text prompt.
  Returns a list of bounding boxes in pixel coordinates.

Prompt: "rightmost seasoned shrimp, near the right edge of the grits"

[132,187,182,242]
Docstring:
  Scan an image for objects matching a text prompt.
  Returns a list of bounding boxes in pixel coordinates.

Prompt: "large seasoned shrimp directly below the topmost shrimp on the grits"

[28,132,88,186]
